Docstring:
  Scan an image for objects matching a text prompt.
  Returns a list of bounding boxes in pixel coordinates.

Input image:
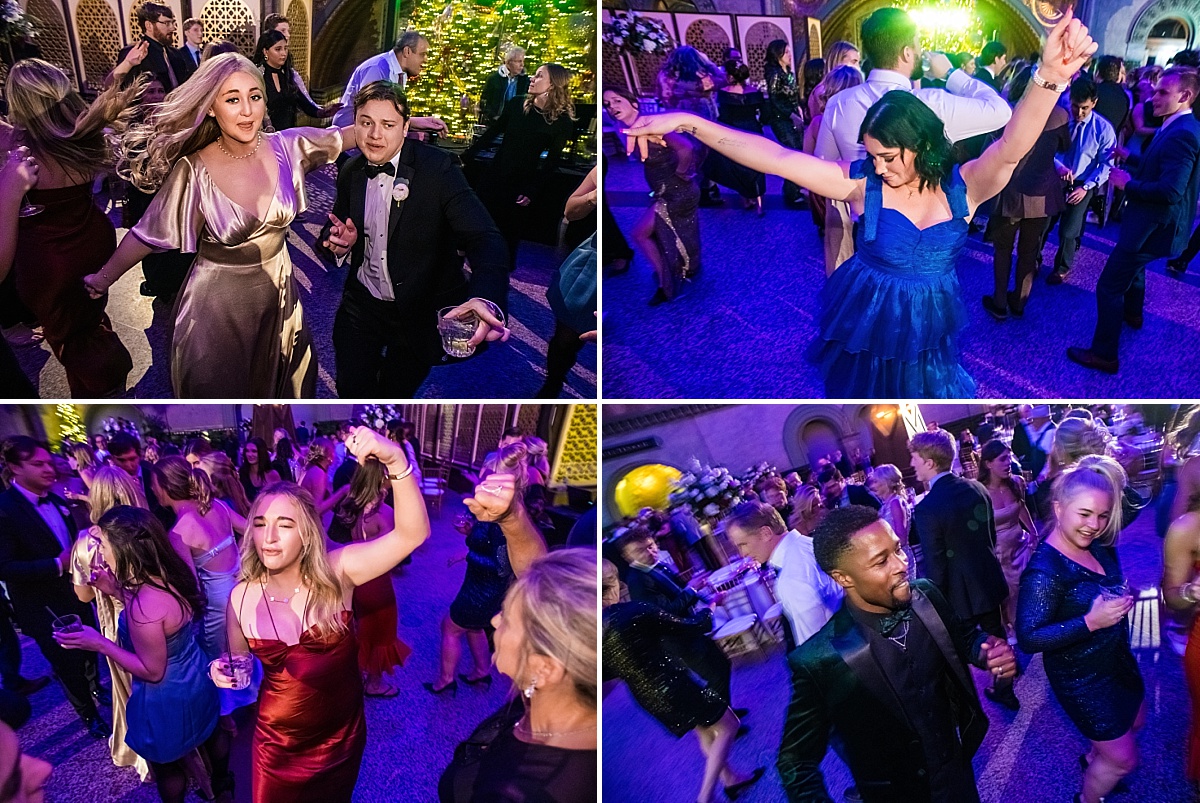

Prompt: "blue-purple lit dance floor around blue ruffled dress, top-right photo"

[602,156,1200,398]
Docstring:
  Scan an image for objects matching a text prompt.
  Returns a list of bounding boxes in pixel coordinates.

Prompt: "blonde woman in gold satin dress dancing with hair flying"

[84,53,355,398]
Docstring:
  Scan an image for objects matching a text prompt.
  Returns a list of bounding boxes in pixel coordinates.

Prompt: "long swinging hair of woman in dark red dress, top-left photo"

[6,59,145,182]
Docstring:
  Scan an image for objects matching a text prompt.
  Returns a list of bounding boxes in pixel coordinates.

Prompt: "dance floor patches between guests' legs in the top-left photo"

[13,166,596,398]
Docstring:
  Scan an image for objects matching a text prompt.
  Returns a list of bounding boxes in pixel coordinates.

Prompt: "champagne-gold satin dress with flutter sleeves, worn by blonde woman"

[132,128,342,398]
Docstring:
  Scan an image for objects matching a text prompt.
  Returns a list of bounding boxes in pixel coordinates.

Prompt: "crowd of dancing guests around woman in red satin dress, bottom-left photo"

[0,421,598,803]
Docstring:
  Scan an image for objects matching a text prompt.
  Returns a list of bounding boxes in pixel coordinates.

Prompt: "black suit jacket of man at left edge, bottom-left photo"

[0,487,91,639]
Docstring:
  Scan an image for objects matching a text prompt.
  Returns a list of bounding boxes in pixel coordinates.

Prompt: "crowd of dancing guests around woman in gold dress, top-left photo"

[0,2,596,398]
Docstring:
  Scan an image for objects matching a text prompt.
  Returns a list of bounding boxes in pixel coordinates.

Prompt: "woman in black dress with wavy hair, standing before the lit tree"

[462,64,575,270]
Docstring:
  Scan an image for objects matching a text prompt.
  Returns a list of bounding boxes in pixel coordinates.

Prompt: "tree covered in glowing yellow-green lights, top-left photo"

[401,0,596,139]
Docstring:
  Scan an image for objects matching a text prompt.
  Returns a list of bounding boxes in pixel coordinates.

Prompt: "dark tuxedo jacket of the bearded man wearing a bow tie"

[776,580,988,803]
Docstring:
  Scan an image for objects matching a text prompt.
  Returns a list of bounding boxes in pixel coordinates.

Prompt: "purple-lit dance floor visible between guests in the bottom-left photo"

[18,493,525,803]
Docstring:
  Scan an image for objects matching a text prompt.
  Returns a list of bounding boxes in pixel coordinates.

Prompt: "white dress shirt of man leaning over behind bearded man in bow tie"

[767,529,844,647]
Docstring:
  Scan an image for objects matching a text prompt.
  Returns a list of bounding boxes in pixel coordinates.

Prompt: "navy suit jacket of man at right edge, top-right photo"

[1117,114,1200,257]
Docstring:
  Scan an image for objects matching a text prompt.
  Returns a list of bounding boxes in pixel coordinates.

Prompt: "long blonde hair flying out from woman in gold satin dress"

[118,53,266,192]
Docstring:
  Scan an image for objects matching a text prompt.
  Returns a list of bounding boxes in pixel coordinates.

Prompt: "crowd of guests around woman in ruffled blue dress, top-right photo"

[604,8,1200,398]
